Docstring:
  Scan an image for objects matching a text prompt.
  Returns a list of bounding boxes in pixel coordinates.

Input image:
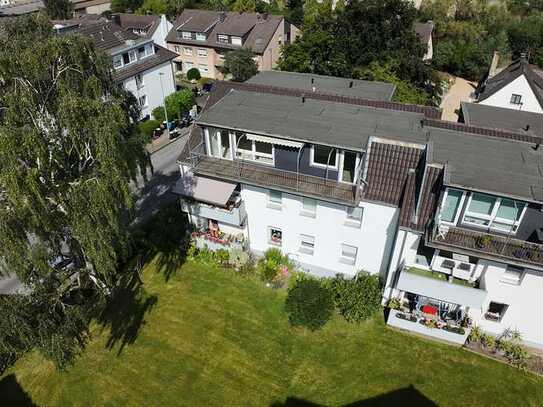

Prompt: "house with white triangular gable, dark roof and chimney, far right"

[476,53,543,113]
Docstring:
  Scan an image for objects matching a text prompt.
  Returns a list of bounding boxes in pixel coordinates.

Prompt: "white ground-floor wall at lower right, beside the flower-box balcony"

[476,260,543,348]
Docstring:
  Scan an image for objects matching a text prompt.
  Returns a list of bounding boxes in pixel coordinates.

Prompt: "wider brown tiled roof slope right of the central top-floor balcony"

[362,141,424,206]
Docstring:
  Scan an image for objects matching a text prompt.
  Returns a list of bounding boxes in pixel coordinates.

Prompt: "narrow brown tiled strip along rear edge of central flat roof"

[206,81,441,119]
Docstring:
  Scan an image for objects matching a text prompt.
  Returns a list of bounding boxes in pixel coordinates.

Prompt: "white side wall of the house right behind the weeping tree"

[123,61,175,117]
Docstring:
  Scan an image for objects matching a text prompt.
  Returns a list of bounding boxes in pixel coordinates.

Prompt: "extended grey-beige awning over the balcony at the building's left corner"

[172,175,236,206]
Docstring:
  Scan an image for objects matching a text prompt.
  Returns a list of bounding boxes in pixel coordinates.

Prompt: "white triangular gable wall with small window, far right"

[479,75,543,113]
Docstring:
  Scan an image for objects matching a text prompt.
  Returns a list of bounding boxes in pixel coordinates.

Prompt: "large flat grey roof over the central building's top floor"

[198,90,426,151]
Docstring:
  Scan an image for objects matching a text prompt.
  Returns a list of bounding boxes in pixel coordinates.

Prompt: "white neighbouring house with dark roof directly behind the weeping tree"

[55,17,176,117]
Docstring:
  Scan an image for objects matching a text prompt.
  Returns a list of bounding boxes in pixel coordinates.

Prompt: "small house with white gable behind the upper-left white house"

[111,13,173,48]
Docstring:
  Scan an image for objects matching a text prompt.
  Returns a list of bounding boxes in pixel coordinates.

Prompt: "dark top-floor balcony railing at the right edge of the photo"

[427,226,543,268]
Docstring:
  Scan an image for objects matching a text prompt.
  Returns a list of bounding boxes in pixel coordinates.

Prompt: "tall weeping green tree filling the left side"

[0,14,148,366]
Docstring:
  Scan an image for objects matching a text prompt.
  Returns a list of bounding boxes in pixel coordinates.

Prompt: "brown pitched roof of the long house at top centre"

[166,9,283,54]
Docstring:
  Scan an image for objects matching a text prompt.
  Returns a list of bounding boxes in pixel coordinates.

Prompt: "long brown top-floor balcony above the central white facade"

[185,153,357,206]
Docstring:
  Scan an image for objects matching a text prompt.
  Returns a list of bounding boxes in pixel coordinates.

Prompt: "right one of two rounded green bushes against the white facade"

[332,272,381,322]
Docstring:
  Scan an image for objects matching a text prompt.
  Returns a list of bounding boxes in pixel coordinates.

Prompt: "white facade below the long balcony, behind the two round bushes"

[241,185,398,275]
